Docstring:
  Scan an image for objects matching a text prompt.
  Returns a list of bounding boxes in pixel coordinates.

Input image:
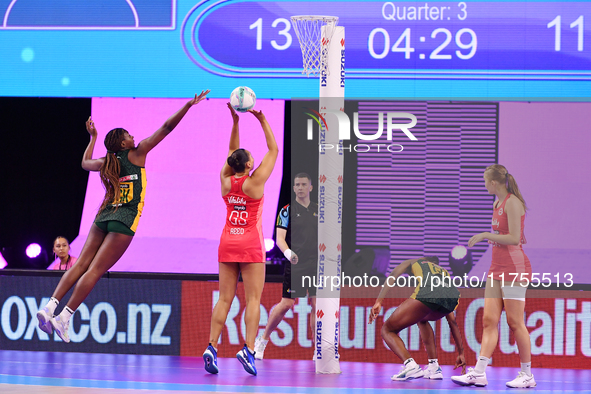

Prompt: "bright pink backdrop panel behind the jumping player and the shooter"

[71,98,285,273]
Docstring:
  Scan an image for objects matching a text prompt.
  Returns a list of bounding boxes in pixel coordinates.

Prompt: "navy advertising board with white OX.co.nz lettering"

[0,276,181,355]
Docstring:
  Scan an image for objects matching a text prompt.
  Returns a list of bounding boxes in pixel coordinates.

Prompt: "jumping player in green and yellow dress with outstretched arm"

[37,90,209,342]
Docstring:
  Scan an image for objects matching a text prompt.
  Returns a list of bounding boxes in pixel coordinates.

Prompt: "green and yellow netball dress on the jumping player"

[95,149,146,233]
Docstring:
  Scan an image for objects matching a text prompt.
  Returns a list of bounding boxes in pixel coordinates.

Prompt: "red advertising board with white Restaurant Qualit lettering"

[181,282,591,369]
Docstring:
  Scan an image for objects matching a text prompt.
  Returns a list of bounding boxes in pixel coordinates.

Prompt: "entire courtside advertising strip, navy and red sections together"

[0,276,591,372]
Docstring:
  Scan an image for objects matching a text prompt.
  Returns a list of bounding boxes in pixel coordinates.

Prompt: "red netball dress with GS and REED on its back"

[218,176,266,263]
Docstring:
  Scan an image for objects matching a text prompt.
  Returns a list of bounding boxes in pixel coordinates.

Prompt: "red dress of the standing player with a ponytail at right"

[488,193,532,282]
